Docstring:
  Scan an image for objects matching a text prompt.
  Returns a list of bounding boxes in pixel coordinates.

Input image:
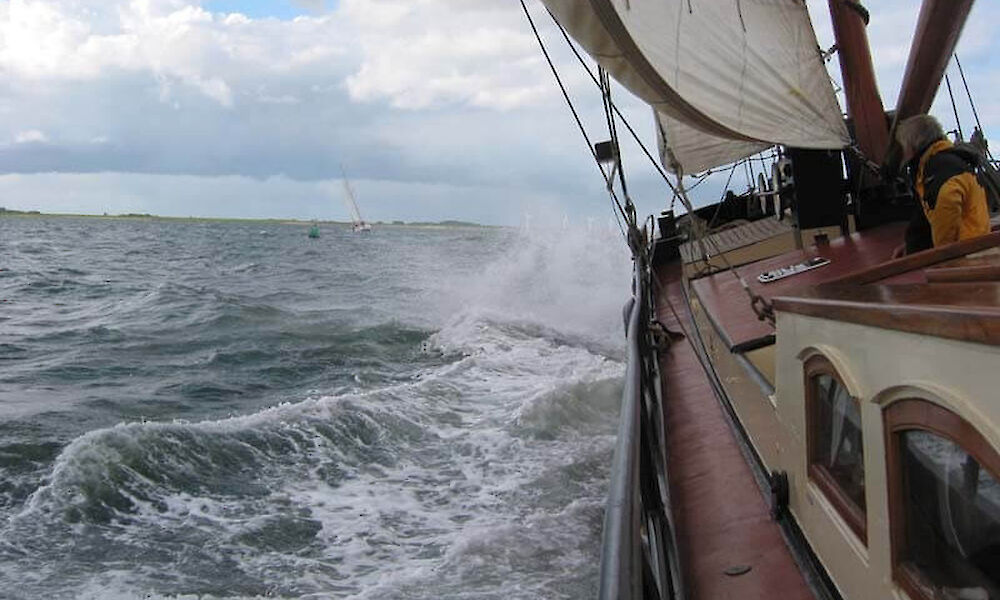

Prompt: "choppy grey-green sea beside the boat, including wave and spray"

[0,218,630,600]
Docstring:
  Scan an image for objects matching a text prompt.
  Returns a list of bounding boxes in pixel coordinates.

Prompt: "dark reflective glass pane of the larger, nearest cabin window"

[900,430,1000,600]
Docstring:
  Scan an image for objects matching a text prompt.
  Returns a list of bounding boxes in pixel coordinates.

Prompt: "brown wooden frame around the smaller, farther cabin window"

[803,354,868,546]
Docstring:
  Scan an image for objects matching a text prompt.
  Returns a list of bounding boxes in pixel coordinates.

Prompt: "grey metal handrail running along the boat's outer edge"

[599,256,683,600]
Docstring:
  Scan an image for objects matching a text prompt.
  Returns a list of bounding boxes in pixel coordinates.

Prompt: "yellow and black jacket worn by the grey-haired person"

[914,139,990,247]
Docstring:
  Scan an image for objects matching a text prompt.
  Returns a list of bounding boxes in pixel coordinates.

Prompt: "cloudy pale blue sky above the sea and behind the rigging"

[0,0,1000,225]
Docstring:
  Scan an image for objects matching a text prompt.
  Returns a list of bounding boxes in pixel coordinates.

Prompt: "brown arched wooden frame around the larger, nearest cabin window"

[883,398,1000,600]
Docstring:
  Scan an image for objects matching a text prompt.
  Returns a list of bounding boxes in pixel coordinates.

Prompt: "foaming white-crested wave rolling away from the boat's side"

[0,310,621,597]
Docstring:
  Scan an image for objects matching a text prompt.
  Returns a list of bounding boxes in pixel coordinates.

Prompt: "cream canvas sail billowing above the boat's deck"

[542,0,850,173]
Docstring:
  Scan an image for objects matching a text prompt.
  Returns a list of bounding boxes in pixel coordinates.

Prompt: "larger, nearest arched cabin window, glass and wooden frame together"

[886,400,1000,600]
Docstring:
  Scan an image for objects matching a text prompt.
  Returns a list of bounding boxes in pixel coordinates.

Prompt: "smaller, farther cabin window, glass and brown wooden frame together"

[805,356,867,543]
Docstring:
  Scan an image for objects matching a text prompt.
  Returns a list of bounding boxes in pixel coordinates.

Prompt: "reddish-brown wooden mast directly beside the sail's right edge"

[829,0,889,162]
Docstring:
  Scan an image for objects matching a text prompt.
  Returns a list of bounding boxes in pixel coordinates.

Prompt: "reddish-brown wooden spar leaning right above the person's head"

[892,0,973,127]
